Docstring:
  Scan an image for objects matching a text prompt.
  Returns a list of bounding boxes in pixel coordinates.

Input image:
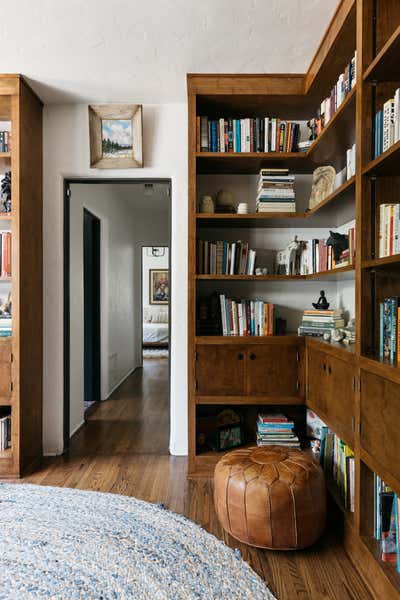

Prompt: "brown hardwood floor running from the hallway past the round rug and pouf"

[24,360,373,600]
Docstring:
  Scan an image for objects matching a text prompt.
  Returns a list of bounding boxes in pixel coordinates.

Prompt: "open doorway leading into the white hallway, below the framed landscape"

[64,179,171,453]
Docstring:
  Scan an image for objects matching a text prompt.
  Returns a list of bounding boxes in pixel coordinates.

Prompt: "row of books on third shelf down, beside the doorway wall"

[197,240,256,275]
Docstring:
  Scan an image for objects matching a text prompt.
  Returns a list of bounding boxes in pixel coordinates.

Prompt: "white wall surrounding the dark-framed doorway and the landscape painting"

[44,103,187,454]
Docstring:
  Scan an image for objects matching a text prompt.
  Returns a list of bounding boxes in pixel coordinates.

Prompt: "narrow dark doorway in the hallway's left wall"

[83,208,101,415]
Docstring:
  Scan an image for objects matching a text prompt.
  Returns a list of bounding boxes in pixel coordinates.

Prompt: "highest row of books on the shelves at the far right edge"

[374,88,400,158]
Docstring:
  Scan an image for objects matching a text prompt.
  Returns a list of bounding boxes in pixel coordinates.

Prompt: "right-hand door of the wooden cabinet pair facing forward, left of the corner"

[247,344,299,397]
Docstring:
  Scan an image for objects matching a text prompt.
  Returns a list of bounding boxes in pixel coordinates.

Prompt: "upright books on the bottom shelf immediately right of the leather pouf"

[320,426,354,512]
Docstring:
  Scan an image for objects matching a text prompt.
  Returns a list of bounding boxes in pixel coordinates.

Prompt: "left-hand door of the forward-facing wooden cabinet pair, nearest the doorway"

[196,345,246,396]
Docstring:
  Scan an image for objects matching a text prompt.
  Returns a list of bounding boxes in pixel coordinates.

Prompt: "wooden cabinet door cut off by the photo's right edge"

[360,370,400,479]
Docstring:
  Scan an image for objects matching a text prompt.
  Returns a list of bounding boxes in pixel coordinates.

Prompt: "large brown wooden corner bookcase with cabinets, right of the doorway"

[187,0,400,598]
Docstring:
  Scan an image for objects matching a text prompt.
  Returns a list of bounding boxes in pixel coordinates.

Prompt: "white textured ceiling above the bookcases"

[0,0,338,104]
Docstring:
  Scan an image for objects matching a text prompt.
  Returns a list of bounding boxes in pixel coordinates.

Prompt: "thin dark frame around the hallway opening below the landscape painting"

[63,177,172,452]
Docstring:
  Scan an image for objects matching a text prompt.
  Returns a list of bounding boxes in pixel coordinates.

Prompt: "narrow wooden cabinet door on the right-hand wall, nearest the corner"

[307,348,328,414]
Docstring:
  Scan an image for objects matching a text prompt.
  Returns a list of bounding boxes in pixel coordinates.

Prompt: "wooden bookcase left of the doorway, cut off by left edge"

[0,75,43,479]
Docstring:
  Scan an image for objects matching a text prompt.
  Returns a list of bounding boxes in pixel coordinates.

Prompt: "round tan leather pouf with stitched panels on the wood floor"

[214,446,326,550]
